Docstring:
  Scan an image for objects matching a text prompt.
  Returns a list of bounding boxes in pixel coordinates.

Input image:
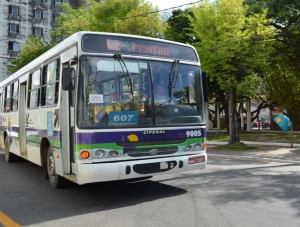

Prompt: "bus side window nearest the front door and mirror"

[41,59,60,106]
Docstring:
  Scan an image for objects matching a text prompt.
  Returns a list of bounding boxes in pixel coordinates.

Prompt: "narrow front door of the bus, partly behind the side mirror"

[59,46,77,174]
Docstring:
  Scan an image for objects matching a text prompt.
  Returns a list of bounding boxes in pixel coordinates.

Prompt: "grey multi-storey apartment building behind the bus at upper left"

[0,0,85,81]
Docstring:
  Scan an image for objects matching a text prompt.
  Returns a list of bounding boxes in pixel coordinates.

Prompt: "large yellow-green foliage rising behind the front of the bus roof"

[51,0,166,40]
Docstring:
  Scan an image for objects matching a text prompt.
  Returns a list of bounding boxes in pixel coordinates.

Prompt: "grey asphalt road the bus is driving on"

[0,152,300,227]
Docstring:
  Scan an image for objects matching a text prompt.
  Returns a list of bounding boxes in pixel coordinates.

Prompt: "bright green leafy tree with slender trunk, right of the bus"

[190,0,273,145]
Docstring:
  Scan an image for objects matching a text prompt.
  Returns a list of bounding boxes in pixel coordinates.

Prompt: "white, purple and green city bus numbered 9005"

[0,32,207,188]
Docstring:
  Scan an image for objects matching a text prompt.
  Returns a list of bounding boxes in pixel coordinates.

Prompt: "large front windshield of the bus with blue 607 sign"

[77,55,204,129]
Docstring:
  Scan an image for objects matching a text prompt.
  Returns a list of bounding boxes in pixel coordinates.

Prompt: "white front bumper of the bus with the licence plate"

[77,153,207,184]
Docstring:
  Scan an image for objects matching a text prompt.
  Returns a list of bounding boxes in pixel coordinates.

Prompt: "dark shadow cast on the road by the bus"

[0,154,187,226]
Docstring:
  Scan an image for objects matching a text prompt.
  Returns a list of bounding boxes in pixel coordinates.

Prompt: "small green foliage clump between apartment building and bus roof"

[8,36,52,73]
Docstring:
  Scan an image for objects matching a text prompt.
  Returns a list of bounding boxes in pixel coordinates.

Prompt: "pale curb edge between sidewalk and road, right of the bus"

[207,154,300,165]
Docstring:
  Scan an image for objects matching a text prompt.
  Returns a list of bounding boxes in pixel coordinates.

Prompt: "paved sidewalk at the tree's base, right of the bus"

[207,141,300,165]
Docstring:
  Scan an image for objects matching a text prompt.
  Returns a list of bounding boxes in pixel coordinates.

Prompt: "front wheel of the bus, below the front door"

[47,146,64,188]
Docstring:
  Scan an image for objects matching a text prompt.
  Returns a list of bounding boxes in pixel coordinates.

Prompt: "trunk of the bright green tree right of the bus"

[228,88,240,145]
